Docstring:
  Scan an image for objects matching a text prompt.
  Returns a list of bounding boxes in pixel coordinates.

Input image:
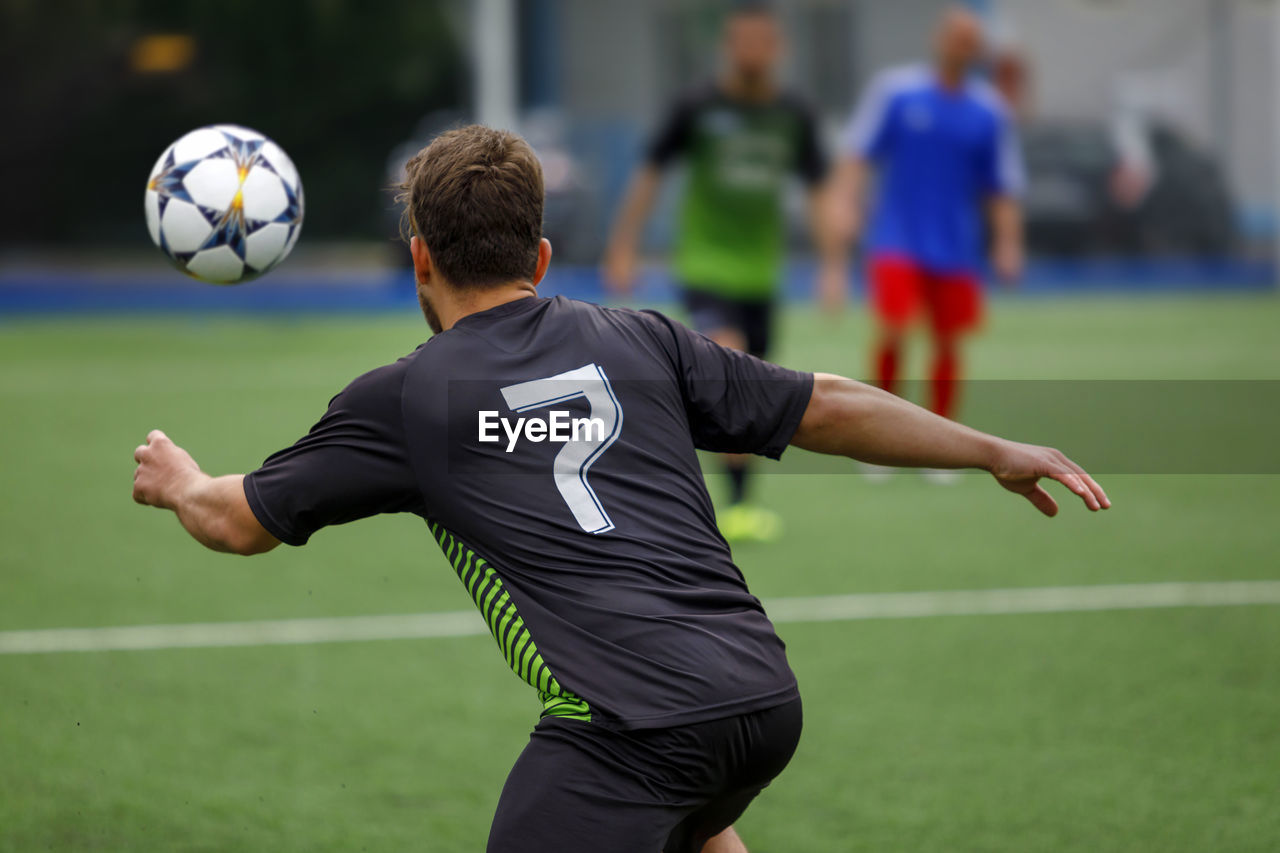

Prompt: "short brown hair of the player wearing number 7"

[397,124,543,288]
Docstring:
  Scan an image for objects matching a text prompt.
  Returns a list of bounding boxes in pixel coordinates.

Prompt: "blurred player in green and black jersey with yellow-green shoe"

[604,3,844,540]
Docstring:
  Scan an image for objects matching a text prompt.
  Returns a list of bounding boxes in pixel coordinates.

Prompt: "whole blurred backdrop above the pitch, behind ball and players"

[0,0,1280,274]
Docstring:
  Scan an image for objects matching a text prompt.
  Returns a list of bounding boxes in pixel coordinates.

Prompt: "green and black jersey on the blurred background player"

[646,86,827,300]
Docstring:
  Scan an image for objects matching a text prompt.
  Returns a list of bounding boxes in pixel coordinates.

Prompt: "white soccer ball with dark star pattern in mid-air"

[146,124,302,284]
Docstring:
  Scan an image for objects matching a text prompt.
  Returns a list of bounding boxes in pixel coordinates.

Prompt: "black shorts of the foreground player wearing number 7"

[488,699,803,853]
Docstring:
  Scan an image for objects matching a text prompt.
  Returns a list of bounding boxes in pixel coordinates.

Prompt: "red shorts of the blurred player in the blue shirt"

[869,255,982,334]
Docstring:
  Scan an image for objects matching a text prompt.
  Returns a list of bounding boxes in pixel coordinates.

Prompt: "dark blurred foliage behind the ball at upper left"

[0,0,468,245]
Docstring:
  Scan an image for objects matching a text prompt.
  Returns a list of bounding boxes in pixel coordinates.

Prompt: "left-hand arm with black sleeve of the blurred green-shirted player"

[600,97,698,296]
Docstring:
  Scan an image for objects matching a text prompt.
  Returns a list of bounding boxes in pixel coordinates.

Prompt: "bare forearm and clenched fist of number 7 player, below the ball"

[133,429,280,556]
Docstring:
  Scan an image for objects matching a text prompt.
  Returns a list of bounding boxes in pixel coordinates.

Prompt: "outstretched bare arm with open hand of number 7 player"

[791,374,1111,516]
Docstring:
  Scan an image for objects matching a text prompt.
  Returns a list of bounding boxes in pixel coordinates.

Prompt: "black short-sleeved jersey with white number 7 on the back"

[244,297,813,727]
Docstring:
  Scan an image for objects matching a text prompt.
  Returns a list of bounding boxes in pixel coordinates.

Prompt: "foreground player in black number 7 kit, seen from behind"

[133,126,1110,853]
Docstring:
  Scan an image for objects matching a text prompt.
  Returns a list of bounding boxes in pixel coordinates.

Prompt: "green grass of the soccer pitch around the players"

[0,290,1280,853]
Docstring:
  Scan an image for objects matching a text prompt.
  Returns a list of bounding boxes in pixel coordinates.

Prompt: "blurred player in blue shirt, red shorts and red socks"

[832,6,1024,479]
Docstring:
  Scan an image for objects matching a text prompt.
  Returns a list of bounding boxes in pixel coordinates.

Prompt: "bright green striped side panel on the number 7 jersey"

[428,521,591,721]
